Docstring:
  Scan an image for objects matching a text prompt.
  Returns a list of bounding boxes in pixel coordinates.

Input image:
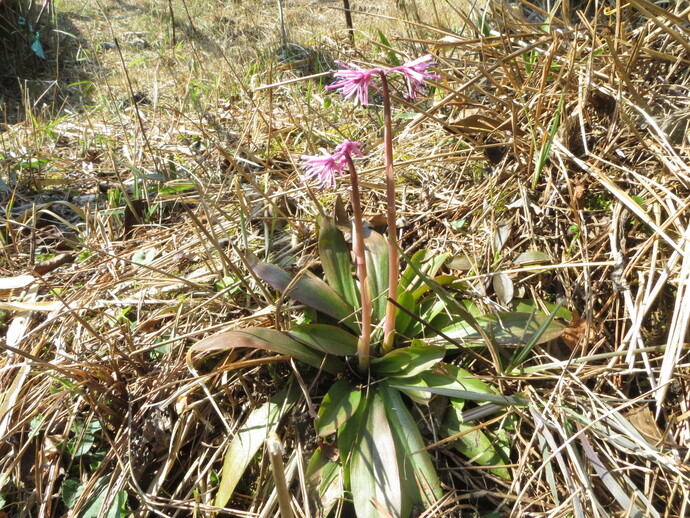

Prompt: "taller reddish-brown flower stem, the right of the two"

[380,72,400,354]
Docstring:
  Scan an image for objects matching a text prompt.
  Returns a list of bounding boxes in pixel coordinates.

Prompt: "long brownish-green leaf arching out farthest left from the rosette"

[187,327,345,374]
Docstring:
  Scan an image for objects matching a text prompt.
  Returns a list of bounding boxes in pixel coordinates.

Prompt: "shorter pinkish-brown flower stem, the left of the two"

[345,154,372,375]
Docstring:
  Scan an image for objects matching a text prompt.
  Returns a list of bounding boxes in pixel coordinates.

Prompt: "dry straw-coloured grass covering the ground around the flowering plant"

[0,0,690,517]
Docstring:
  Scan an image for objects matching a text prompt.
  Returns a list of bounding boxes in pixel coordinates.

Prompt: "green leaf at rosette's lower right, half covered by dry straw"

[440,405,510,480]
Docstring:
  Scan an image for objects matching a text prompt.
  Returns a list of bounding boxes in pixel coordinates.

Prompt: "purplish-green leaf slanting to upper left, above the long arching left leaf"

[249,255,359,332]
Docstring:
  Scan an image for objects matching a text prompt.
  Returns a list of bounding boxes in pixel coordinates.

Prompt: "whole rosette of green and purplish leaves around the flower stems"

[189,217,563,518]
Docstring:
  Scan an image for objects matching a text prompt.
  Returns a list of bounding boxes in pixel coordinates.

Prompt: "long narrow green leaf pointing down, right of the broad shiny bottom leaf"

[381,383,443,508]
